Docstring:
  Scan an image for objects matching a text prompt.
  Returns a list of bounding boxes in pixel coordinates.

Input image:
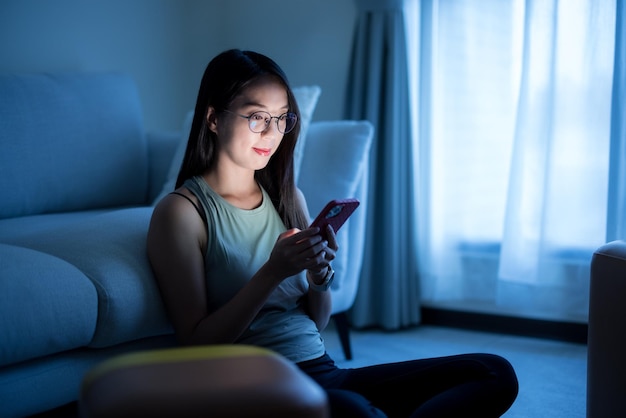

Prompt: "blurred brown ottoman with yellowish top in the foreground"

[79,345,330,418]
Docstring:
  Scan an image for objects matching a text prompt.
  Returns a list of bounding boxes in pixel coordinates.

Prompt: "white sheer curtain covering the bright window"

[405,0,615,322]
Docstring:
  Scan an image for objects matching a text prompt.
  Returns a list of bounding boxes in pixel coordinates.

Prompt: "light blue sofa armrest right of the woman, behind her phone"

[298,120,374,314]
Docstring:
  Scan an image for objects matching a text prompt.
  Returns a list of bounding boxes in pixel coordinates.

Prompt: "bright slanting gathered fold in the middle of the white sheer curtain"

[499,0,558,282]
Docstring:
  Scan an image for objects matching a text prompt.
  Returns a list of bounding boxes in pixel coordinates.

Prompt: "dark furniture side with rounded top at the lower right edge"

[587,240,626,418]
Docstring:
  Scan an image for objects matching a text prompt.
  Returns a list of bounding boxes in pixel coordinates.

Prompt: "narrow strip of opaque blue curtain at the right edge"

[606,0,626,241]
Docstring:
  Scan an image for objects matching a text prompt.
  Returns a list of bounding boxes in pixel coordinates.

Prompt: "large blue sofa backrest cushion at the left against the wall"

[0,73,148,219]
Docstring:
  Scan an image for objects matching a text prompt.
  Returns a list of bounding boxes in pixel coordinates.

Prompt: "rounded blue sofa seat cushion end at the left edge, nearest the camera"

[0,244,98,367]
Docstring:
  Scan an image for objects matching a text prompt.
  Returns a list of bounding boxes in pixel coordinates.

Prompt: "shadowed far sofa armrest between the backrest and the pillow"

[146,132,180,204]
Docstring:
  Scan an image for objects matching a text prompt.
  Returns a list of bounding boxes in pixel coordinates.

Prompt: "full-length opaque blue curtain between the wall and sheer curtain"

[346,0,420,329]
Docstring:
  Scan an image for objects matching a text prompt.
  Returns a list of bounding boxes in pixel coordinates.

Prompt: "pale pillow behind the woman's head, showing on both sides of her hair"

[153,85,322,205]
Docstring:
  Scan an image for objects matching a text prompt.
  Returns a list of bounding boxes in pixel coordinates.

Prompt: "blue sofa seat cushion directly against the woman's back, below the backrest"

[0,207,173,347]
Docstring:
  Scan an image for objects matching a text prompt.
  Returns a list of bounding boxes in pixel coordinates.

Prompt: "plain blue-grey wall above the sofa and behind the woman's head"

[0,0,356,130]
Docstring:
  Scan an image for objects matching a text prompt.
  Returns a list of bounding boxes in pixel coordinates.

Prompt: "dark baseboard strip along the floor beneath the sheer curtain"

[421,307,588,344]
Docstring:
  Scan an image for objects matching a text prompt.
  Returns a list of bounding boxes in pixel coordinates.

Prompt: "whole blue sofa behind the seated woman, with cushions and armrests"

[0,73,373,417]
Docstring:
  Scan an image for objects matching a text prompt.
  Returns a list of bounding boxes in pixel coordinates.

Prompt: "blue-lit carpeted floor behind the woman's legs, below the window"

[324,326,587,418]
